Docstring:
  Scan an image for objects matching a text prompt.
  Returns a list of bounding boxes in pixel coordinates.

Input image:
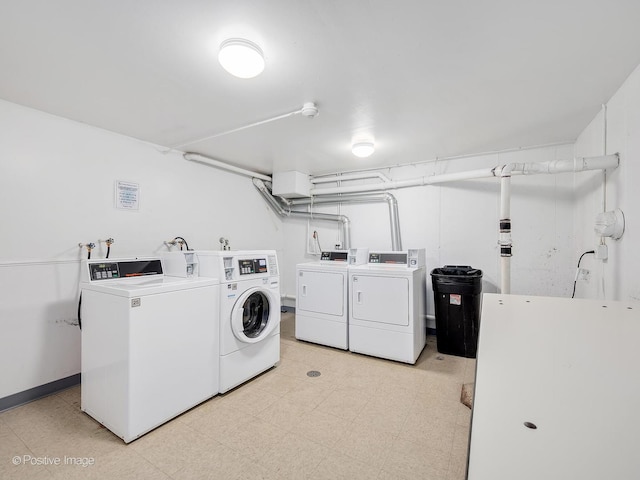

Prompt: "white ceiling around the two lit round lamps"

[0,0,640,175]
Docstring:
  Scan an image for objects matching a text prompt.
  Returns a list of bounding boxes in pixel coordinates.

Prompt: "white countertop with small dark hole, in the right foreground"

[468,294,640,480]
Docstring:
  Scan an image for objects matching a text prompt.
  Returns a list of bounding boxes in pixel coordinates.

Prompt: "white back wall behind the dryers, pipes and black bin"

[282,145,575,328]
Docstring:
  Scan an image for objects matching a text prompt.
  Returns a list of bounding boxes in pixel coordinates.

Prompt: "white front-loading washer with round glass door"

[196,250,280,393]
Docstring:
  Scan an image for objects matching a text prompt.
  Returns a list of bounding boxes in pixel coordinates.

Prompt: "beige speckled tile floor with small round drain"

[0,313,475,480]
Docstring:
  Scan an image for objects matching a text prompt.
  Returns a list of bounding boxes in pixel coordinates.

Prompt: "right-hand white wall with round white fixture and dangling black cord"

[575,61,640,301]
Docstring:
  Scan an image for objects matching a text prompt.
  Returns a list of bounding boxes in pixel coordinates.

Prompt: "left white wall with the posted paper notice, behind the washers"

[0,101,283,398]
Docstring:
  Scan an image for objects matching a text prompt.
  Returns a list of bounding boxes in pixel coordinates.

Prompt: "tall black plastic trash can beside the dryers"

[431,265,482,358]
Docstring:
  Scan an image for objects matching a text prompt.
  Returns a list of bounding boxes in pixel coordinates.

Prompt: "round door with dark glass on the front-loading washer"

[231,288,280,343]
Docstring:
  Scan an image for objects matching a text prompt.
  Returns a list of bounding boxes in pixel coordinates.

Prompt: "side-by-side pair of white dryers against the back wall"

[295,249,426,364]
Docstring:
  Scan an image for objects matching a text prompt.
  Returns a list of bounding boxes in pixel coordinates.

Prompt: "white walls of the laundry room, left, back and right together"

[6,53,640,398]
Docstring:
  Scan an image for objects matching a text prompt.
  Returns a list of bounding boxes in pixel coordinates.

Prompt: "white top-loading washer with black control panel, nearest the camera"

[80,258,220,443]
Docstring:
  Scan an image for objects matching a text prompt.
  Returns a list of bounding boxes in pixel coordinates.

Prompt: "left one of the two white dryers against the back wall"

[295,248,368,350]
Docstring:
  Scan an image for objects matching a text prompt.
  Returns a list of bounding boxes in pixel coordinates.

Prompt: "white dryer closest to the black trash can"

[349,249,427,364]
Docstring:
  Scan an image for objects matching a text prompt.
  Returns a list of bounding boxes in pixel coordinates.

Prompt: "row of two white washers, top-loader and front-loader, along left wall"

[80,251,280,443]
